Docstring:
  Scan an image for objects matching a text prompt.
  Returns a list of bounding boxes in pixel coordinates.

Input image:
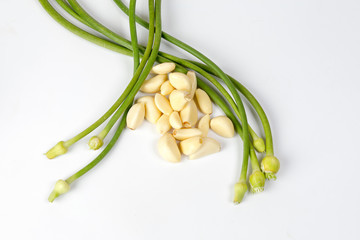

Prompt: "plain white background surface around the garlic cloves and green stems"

[0,0,360,240]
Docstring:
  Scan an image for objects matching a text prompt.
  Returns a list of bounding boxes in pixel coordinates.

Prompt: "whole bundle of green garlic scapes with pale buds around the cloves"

[39,0,280,203]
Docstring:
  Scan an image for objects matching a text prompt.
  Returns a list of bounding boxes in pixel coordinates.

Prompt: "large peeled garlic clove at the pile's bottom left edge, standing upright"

[158,133,181,162]
